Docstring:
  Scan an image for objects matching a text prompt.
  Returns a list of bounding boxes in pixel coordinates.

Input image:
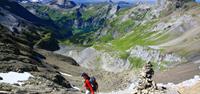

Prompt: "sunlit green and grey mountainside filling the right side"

[60,0,200,72]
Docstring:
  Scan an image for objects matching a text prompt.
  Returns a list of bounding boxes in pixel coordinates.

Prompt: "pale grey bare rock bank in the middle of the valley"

[56,47,131,72]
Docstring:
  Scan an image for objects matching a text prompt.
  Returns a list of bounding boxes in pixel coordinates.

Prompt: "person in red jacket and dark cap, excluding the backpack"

[81,73,94,94]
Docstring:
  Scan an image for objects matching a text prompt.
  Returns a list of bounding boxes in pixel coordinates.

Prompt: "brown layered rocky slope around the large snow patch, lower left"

[0,26,78,94]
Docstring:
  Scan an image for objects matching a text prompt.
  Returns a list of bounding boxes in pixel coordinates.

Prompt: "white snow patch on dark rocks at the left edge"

[0,72,33,85]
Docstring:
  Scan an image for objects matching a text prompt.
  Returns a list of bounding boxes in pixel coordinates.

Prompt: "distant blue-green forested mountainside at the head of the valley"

[22,3,123,45]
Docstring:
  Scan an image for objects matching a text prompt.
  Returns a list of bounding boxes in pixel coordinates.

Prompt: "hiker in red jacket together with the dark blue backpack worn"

[81,73,98,94]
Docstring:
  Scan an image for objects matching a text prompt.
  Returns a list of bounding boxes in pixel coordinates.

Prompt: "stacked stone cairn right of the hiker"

[134,62,165,94]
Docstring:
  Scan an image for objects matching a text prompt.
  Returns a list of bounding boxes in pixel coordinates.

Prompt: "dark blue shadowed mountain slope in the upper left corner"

[0,0,59,50]
